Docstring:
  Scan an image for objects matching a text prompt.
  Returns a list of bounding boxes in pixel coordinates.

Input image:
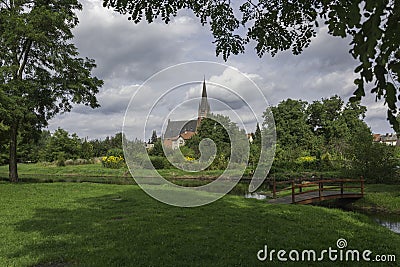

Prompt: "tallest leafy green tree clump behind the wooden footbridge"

[271,96,371,172]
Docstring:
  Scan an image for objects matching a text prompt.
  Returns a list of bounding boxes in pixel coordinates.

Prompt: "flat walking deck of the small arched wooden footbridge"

[268,190,363,204]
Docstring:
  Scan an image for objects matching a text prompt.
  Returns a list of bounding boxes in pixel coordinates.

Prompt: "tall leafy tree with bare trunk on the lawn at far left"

[0,0,103,182]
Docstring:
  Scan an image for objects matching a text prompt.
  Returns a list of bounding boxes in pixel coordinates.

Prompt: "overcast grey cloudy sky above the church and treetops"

[49,0,392,139]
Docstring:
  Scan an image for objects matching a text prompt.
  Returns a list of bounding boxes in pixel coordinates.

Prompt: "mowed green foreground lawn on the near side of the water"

[0,182,400,266]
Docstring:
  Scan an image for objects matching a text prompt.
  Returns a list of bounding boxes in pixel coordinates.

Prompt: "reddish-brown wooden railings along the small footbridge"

[272,177,364,203]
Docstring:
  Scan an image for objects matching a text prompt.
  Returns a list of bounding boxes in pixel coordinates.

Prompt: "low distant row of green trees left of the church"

[0,128,123,165]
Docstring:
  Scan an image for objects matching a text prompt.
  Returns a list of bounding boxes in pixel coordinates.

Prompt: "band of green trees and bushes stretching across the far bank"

[0,96,400,182]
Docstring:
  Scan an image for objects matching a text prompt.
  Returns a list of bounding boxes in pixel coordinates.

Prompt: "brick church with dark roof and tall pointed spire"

[162,79,210,149]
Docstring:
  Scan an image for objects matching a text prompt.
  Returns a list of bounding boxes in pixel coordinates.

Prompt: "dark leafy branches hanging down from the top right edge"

[103,0,400,131]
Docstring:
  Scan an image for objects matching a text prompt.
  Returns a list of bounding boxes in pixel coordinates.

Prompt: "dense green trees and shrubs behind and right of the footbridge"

[272,96,400,182]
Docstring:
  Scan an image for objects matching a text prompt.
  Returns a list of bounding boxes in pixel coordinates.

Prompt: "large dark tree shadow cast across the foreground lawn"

[8,188,400,266]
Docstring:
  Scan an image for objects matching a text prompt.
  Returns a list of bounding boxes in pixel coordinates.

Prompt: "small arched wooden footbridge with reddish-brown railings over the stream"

[269,177,364,204]
